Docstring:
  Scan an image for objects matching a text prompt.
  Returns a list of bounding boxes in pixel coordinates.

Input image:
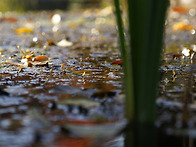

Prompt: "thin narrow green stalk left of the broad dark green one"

[114,0,134,120]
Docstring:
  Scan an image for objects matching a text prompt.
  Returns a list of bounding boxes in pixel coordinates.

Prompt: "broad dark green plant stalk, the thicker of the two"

[128,0,168,124]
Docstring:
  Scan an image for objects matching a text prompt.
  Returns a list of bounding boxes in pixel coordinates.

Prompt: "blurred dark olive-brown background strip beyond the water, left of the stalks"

[0,0,111,12]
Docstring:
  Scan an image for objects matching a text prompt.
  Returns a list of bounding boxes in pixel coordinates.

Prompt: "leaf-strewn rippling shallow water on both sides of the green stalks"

[0,5,196,147]
